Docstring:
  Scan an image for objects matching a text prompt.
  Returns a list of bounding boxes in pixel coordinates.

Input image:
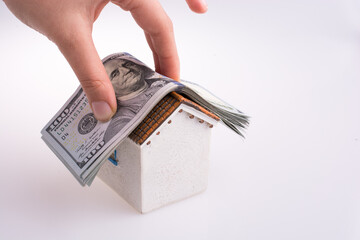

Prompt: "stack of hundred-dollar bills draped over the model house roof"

[41,53,249,186]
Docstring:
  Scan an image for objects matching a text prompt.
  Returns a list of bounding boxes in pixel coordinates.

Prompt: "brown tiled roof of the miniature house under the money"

[129,92,219,145]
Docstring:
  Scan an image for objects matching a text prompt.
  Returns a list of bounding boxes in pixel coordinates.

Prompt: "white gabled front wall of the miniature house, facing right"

[141,104,215,212]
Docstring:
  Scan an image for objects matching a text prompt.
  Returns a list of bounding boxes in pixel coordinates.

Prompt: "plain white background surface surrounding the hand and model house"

[0,0,360,240]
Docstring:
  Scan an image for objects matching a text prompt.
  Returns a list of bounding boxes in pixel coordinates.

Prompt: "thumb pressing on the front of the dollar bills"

[55,28,116,122]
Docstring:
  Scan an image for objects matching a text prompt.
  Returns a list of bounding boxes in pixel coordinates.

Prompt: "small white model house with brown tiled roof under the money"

[98,93,219,213]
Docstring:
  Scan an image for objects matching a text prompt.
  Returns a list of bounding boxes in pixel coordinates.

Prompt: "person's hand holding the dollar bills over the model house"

[4,0,207,121]
